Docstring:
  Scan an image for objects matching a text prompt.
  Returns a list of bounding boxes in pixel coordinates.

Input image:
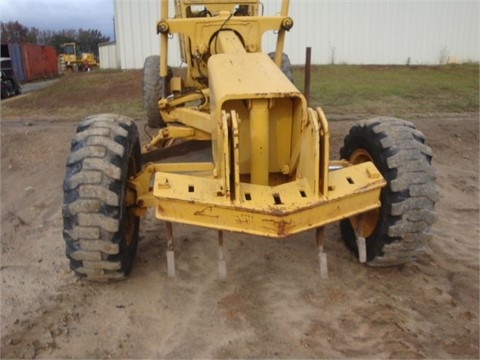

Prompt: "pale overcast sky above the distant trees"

[0,0,113,40]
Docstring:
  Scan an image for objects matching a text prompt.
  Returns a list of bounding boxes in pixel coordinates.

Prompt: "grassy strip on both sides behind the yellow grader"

[1,64,479,121]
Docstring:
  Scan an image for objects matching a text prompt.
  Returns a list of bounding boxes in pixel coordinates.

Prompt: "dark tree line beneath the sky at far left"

[0,21,110,56]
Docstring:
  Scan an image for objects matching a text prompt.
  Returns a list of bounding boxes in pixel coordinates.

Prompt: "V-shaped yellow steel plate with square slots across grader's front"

[153,163,385,238]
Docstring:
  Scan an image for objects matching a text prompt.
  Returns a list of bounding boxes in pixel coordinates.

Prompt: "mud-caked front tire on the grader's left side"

[62,114,141,281]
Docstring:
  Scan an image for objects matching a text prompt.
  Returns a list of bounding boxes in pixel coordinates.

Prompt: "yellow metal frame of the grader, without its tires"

[129,0,385,270]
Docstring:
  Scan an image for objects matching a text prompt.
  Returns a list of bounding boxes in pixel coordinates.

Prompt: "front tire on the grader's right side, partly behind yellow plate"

[340,117,438,266]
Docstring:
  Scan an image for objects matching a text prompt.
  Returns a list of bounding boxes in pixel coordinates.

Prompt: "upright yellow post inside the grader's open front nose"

[250,99,270,185]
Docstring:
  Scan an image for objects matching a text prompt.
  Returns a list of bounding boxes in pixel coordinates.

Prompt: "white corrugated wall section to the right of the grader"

[266,0,480,64]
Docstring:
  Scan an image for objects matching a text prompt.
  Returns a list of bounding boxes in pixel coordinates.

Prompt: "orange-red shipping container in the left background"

[20,43,58,82]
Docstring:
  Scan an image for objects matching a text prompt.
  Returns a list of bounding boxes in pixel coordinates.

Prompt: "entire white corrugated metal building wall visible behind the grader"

[114,0,480,69]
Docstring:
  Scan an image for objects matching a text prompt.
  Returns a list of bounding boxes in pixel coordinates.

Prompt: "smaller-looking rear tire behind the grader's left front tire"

[143,55,172,128]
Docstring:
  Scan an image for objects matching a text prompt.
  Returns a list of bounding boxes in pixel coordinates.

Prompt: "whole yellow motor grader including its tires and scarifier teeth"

[63,0,437,280]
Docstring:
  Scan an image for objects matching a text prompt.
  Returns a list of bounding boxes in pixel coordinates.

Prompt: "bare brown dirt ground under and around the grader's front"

[0,107,480,359]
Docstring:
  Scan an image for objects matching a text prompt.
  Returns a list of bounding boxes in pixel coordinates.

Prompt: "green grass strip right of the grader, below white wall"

[294,64,479,115]
